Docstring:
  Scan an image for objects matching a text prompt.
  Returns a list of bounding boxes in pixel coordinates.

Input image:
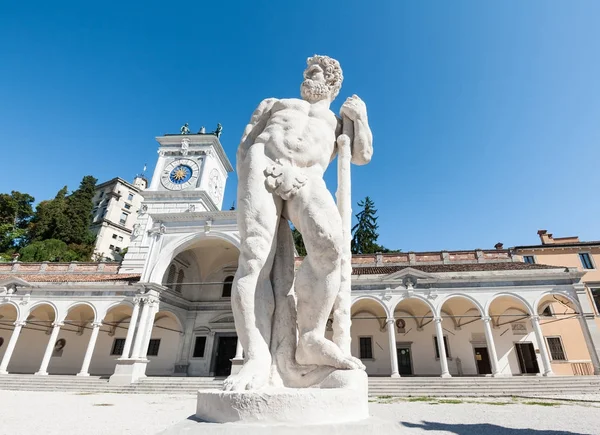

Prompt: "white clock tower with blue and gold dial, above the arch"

[121,128,233,273]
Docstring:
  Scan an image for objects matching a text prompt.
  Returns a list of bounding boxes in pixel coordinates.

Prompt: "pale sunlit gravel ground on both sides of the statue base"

[0,391,600,435]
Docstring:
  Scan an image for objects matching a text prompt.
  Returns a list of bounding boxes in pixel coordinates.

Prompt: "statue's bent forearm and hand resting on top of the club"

[340,95,373,165]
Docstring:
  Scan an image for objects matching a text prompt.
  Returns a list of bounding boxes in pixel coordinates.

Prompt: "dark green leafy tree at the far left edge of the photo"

[0,190,35,252]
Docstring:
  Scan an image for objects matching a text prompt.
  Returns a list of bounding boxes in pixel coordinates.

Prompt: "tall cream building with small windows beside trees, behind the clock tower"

[90,176,148,261]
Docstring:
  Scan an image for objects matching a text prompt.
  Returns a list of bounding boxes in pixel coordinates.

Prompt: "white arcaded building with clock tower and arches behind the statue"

[0,134,600,383]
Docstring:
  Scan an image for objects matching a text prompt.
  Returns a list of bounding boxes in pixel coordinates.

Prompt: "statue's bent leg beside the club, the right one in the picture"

[286,178,364,369]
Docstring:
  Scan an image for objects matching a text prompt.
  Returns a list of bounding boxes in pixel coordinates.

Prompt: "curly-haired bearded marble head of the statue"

[300,54,344,103]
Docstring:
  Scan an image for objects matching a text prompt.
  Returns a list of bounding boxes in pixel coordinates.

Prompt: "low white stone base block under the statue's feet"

[196,370,369,424]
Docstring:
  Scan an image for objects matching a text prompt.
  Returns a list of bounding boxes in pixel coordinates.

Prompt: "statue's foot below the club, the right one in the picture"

[296,334,365,370]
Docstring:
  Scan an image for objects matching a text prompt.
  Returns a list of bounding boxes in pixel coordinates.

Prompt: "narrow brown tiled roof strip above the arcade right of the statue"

[352,262,564,275]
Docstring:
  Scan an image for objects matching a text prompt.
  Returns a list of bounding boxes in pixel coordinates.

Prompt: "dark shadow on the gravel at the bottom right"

[400,421,586,435]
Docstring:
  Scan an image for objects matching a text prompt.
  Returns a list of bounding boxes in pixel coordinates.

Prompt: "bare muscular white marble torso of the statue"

[255,98,338,176]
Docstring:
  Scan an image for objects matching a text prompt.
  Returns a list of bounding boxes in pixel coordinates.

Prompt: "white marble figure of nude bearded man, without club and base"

[225,55,373,390]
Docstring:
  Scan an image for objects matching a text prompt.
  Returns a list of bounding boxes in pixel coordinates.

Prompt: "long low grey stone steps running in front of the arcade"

[0,374,600,397]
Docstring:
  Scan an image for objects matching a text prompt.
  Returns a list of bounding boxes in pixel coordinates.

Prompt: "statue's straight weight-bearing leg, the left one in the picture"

[224,144,282,390]
